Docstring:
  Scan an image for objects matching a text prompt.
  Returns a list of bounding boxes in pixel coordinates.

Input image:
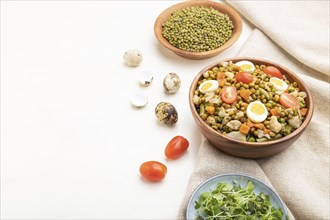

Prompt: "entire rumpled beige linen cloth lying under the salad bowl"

[179,1,330,219]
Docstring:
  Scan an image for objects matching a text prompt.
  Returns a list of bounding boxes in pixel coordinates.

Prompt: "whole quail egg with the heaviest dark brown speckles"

[155,102,178,125]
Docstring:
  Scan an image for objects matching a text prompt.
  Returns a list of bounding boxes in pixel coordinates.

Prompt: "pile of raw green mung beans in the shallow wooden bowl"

[162,6,234,52]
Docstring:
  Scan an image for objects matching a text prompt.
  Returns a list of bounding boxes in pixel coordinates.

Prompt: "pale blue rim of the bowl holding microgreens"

[186,173,288,219]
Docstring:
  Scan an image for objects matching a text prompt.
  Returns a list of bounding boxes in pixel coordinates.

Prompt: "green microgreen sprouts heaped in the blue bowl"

[195,180,283,220]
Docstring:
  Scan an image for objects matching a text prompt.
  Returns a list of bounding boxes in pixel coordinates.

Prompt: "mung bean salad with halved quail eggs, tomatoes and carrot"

[193,61,308,142]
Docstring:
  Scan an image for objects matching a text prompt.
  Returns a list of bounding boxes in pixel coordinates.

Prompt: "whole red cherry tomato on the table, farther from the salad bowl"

[140,161,167,182]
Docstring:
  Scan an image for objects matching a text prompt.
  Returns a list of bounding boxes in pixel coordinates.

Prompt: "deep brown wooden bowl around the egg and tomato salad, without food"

[189,57,314,158]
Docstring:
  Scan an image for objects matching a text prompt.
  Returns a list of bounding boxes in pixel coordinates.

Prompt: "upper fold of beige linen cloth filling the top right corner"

[227,0,330,74]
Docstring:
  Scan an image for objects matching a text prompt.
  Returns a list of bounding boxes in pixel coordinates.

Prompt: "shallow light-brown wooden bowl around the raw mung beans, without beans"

[154,0,242,60]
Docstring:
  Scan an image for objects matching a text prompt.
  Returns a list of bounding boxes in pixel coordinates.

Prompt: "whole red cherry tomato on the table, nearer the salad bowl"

[165,136,189,160]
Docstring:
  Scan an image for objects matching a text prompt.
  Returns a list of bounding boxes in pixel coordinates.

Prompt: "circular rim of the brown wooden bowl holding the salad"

[189,56,314,148]
